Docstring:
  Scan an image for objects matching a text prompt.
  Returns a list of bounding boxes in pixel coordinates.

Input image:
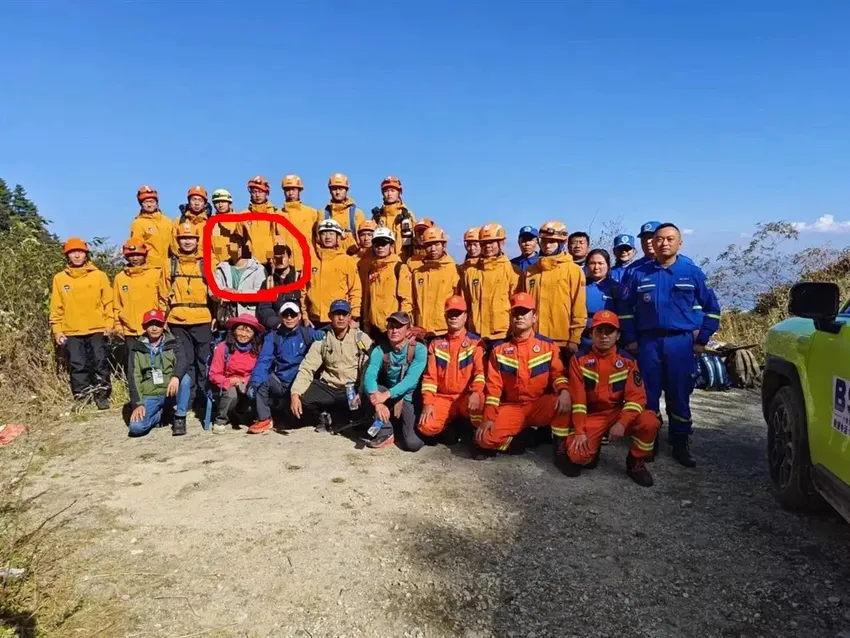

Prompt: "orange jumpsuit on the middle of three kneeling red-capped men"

[478,334,570,450]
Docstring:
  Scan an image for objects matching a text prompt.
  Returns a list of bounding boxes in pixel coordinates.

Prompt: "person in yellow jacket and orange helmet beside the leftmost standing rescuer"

[112,238,168,355]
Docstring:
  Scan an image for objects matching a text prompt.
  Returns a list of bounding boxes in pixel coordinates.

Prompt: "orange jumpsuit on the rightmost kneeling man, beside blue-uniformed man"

[559,348,659,465]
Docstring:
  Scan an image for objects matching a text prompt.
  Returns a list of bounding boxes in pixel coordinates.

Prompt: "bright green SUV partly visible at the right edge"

[761,282,850,521]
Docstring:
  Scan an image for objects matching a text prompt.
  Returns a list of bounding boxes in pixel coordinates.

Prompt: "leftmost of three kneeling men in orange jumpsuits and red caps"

[418,295,485,445]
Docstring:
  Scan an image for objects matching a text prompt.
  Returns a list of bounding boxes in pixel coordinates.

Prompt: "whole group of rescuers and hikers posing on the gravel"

[50,173,720,486]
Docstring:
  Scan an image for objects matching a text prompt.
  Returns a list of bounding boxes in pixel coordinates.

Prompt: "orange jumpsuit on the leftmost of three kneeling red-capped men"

[419,329,484,436]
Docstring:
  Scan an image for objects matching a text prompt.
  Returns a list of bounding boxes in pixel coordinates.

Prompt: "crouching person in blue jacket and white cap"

[248,301,325,434]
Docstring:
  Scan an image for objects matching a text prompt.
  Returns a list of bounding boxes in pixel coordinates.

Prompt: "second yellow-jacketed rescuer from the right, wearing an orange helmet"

[460,223,519,345]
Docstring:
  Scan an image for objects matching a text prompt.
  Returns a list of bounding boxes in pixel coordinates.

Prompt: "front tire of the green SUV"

[767,385,823,511]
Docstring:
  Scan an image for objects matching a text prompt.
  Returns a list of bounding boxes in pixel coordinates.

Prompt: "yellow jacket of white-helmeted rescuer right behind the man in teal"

[363,255,413,332]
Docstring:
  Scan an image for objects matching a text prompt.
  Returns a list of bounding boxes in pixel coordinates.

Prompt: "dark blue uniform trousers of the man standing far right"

[638,332,694,435]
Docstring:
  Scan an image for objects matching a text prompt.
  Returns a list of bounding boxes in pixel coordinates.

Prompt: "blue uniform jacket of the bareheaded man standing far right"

[618,258,720,345]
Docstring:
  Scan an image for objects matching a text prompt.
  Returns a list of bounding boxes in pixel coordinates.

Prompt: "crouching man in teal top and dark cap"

[363,312,428,452]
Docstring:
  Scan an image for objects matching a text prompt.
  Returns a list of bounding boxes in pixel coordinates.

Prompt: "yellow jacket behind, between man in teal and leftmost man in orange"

[411,254,460,336]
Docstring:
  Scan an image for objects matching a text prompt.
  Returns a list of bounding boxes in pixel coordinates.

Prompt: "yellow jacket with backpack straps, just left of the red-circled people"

[162,254,212,326]
